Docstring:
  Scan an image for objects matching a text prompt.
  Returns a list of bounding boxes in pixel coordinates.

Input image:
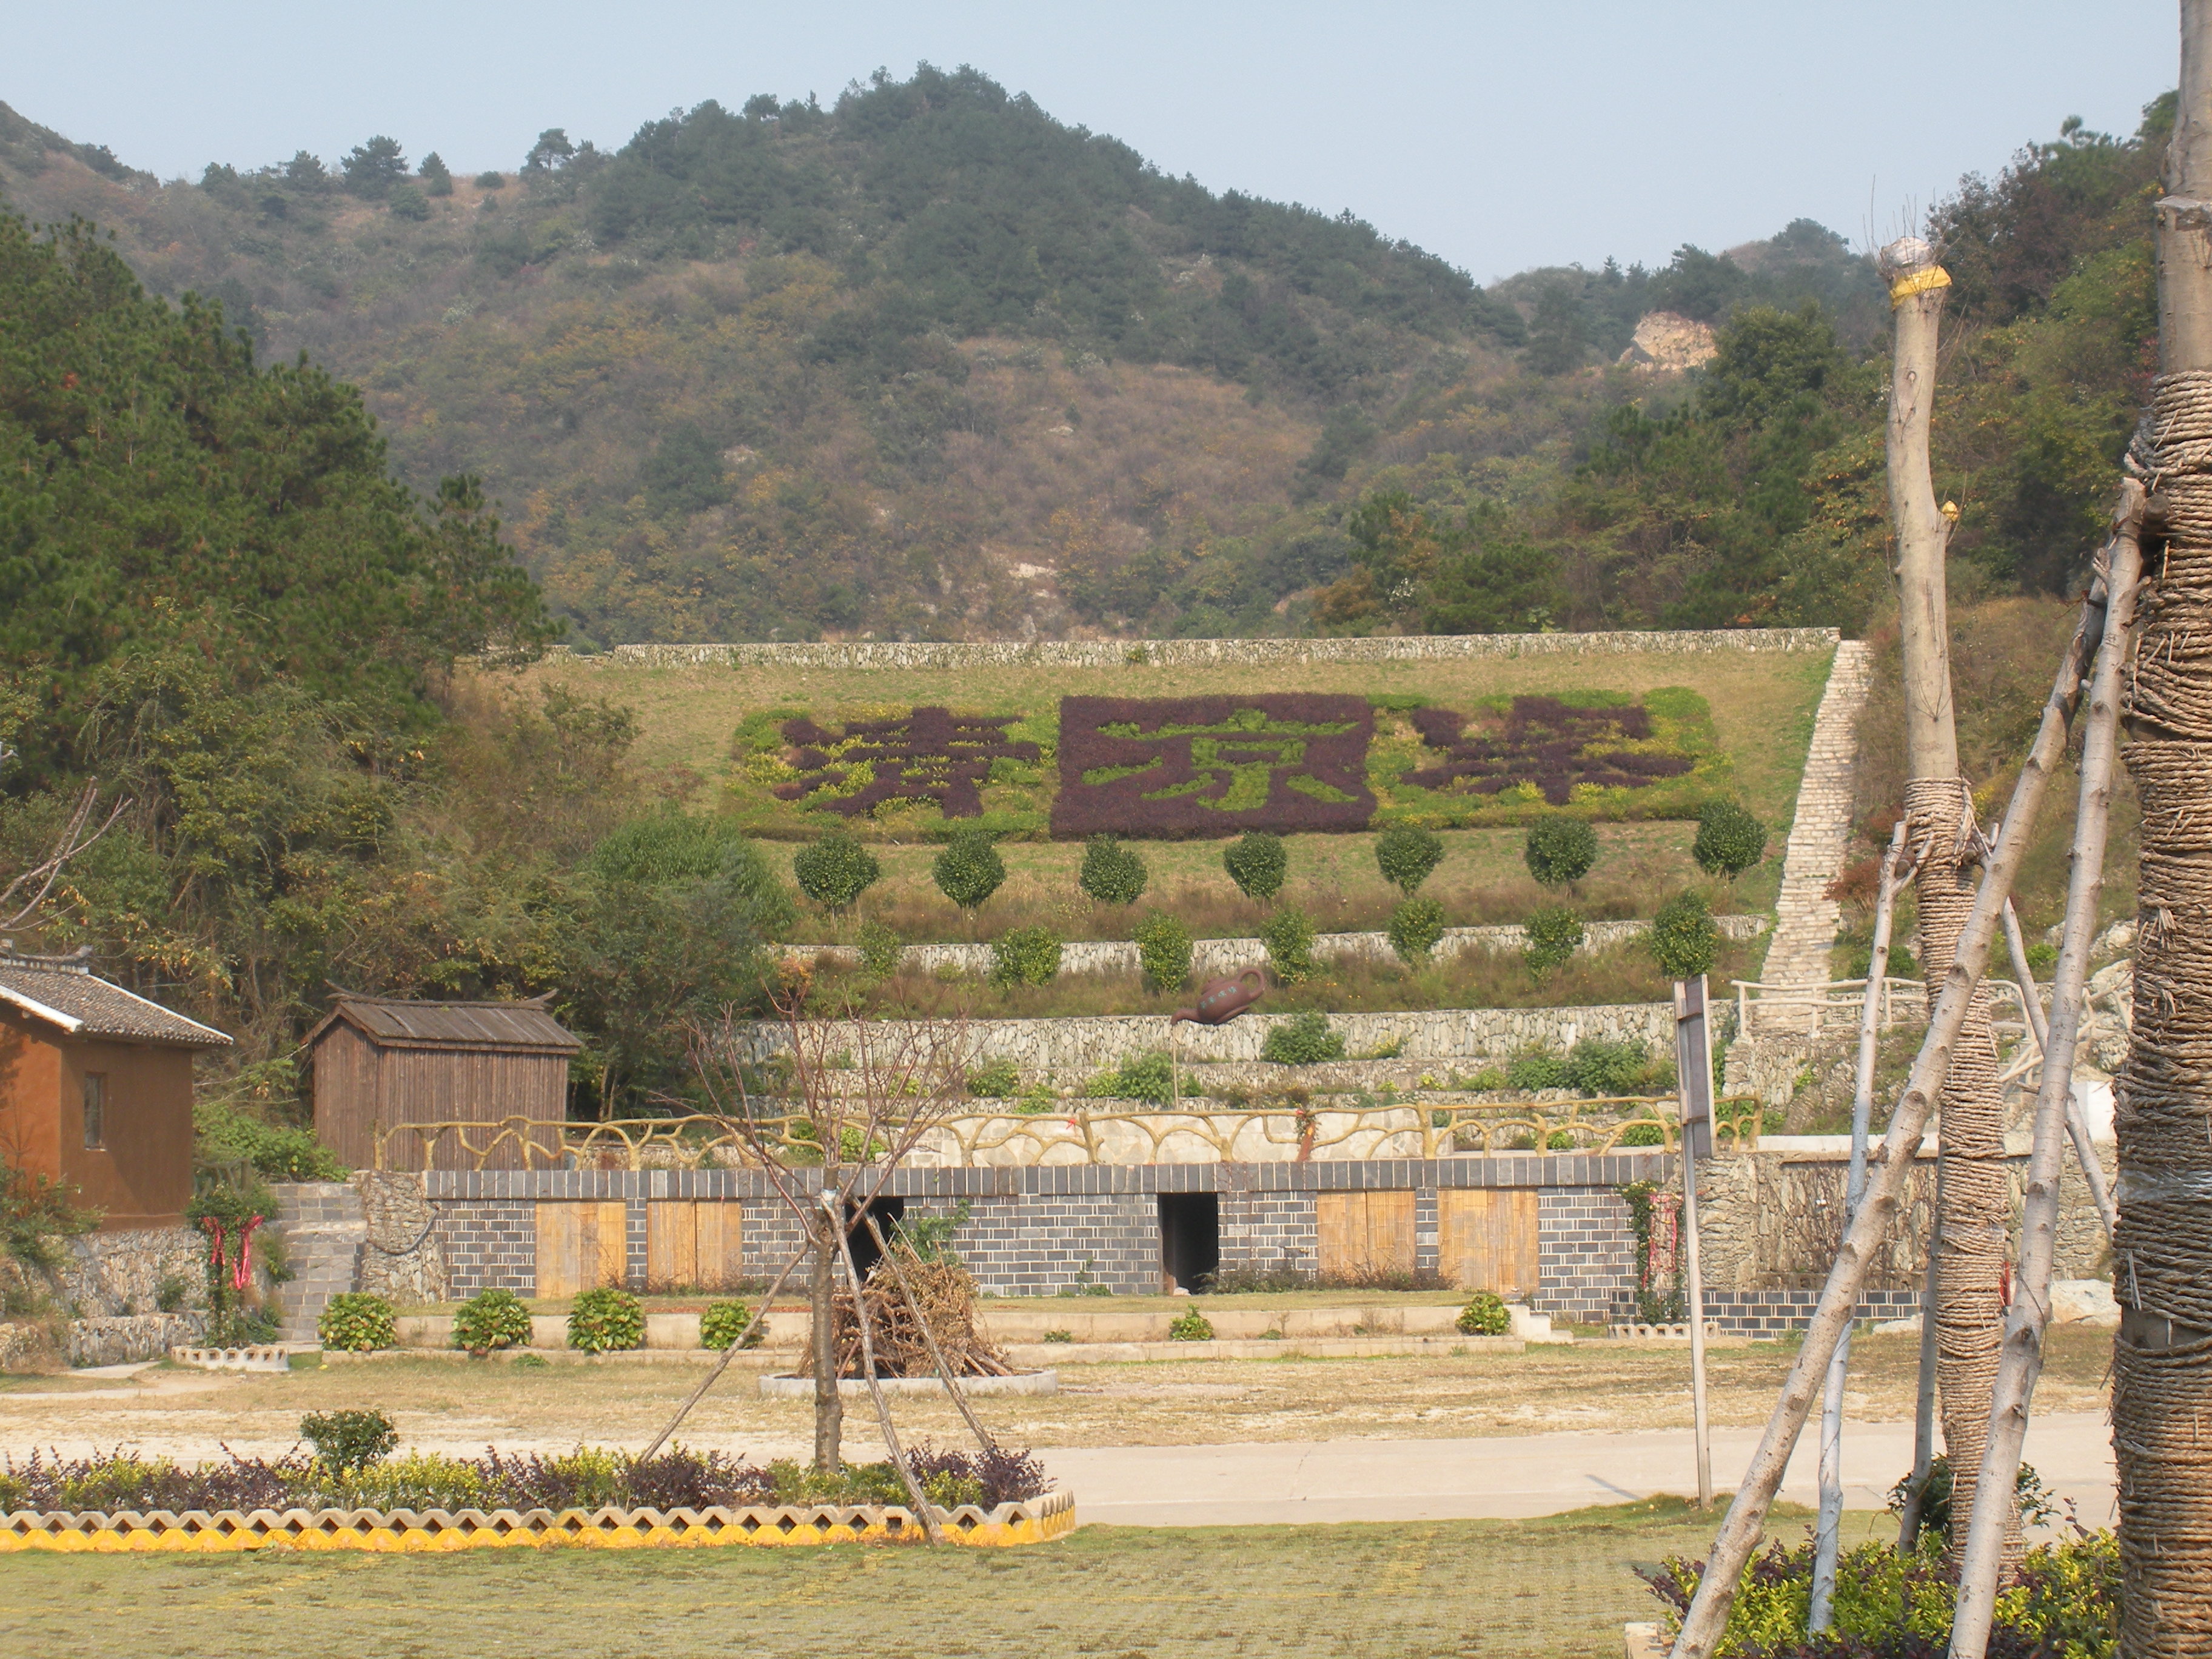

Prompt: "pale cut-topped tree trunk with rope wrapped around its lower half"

[1882,236,2017,1568]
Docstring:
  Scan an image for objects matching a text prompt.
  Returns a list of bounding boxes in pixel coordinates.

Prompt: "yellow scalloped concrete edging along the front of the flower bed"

[0,1491,1075,1555]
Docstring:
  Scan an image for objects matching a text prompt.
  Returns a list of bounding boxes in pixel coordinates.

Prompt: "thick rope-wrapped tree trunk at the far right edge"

[2113,0,2212,1659]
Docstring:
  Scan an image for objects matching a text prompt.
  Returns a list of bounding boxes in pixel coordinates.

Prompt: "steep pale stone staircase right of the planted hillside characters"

[1750,639,1874,1035]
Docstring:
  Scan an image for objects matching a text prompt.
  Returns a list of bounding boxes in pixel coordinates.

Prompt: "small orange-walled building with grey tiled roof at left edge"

[0,951,230,1232]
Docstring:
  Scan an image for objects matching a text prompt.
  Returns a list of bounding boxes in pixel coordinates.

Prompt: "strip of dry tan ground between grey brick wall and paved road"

[0,1327,2113,1458]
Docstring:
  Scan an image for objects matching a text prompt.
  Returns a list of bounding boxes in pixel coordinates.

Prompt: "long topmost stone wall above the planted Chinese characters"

[580,628,1843,668]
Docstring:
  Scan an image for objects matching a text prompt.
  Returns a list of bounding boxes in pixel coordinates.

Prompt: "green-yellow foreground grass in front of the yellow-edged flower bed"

[0,1498,1887,1659]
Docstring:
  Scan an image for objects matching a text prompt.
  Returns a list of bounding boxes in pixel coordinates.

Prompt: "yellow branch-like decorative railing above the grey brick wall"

[376,1095,1763,1170]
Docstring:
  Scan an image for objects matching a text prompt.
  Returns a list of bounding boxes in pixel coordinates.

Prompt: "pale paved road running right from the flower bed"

[1040,1411,2113,1526]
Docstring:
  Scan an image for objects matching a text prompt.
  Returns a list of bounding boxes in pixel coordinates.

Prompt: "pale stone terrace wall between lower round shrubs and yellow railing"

[732,1002,1675,1082]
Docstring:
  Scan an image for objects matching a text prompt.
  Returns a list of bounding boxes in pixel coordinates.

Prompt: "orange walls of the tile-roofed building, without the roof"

[0,1015,192,1232]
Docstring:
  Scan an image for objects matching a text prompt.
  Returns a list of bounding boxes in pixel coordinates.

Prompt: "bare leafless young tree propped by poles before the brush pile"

[692,997,969,1484]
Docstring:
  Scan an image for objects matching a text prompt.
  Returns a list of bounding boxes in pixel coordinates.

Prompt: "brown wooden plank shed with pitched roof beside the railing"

[307,993,584,1170]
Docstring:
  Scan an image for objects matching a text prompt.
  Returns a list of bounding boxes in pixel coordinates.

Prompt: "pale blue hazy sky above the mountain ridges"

[0,0,2177,281]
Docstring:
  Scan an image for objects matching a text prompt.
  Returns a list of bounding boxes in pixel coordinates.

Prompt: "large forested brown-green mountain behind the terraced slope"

[0,66,1880,644]
